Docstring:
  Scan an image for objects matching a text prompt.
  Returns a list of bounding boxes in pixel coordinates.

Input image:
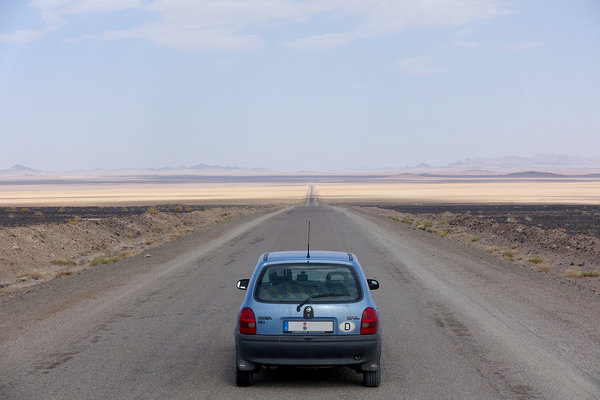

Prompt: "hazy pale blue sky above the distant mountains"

[0,0,600,170]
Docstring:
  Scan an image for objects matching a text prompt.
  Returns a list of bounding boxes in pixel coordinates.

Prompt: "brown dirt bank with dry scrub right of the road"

[357,206,600,293]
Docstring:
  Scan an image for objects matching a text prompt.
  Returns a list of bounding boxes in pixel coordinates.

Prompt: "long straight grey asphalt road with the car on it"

[0,199,600,400]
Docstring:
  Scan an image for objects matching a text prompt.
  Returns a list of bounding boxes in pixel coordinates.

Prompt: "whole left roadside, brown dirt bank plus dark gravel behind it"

[0,205,272,294]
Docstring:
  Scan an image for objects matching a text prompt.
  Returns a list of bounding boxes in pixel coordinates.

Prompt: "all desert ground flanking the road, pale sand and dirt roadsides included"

[0,176,600,292]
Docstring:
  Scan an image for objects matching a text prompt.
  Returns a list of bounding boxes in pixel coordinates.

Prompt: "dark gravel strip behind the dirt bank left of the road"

[0,204,241,228]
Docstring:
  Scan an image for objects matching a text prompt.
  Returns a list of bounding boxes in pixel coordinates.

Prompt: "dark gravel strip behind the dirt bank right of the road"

[357,204,600,237]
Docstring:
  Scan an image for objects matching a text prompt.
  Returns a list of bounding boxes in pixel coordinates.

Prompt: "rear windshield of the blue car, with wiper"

[254,264,362,303]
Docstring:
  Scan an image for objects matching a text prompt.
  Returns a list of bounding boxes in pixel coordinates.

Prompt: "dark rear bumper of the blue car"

[235,333,381,370]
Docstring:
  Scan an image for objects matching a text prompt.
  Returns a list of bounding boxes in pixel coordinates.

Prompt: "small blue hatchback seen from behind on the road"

[235,251,381,387]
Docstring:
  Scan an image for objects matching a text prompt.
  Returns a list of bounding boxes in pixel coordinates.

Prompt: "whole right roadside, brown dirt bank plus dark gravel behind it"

[351,205,600,294]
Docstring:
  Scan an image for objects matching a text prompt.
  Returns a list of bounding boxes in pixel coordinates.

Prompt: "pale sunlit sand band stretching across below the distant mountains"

[0,180,600,207]
